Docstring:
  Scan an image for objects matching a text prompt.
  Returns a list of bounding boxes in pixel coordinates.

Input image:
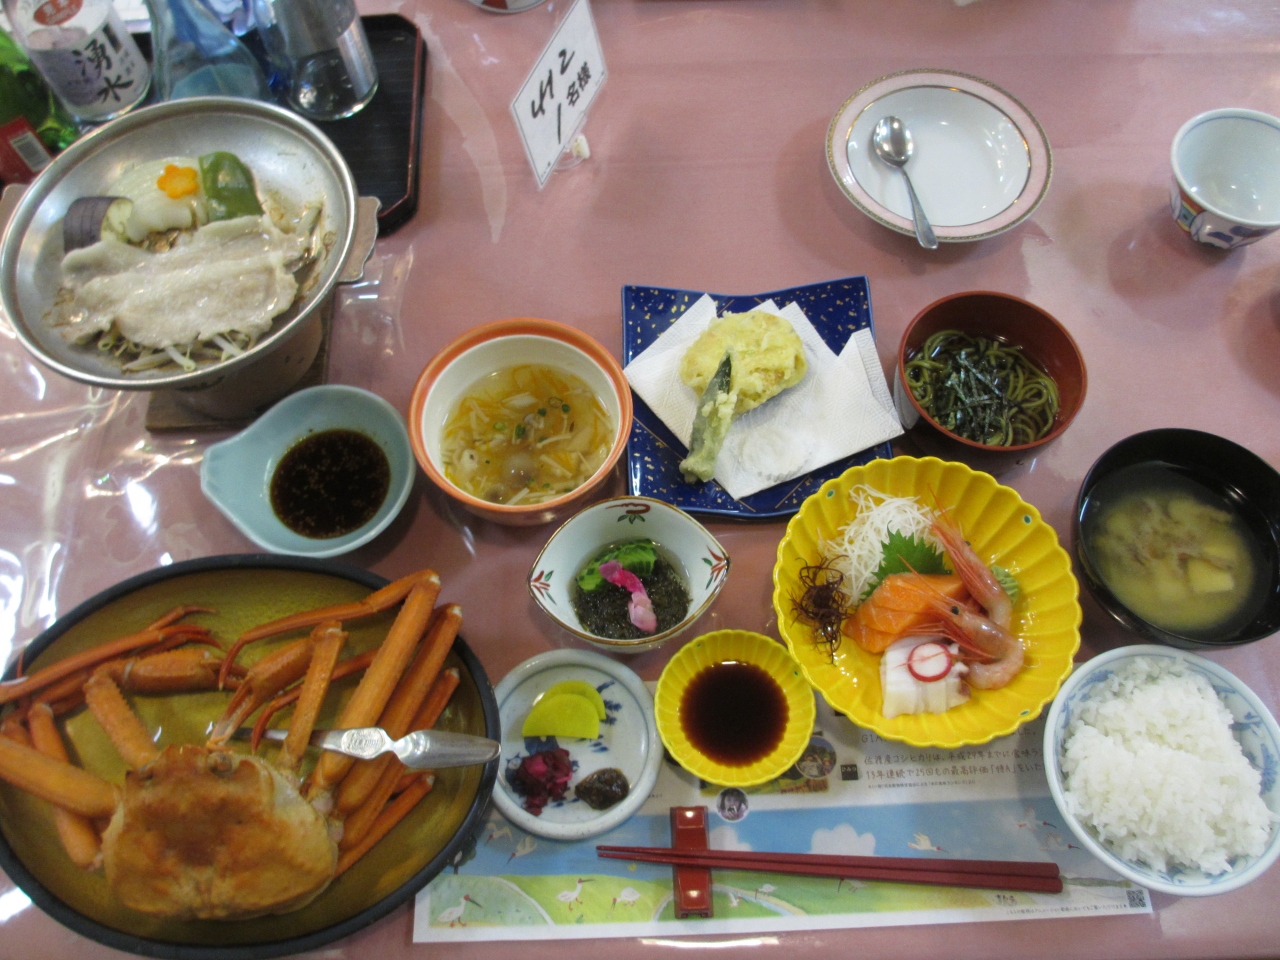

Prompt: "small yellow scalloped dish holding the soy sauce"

[653,630,817,787]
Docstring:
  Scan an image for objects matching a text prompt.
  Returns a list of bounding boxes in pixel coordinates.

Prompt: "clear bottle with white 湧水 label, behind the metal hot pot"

[4,0,151,123]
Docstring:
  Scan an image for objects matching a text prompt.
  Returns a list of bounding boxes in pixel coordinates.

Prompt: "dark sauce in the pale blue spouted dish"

[271,429,392,540]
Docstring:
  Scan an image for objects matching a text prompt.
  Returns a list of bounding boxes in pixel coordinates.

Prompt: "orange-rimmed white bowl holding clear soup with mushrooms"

[408,317,631,526]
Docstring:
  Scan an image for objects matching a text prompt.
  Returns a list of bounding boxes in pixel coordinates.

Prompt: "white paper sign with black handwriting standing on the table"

[511,0,605,189]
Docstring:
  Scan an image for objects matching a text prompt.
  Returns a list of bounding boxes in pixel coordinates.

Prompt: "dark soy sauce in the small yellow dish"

[680,660,788,767]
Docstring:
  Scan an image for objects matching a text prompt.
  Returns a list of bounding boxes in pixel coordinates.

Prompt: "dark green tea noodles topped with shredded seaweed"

[905,330,1059,447]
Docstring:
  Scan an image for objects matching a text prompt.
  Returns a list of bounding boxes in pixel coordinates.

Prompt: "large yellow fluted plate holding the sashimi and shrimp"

[773,457,1082,749]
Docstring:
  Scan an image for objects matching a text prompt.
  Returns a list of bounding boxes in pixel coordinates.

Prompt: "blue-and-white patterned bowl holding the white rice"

[1044,644,1280,896]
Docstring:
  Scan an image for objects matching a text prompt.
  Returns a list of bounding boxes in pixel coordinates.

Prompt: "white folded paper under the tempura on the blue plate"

[625,294,902,499]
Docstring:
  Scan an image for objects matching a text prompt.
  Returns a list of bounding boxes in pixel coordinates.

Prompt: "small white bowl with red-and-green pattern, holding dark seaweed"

[529,497,730,653]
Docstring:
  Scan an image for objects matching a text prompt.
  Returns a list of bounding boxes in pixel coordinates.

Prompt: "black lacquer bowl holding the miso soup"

[1071,429,1280,650]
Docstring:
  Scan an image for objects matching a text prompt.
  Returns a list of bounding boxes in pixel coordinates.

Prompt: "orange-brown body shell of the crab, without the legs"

[102,745,338,920]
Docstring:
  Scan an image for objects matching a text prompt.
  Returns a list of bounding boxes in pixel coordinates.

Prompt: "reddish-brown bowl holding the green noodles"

[896,291,1088,453]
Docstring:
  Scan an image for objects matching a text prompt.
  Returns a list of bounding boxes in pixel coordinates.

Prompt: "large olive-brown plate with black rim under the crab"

[0,556,500,960]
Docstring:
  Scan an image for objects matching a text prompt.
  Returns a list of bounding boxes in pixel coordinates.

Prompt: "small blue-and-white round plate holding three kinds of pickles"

[493,650,662,841]
